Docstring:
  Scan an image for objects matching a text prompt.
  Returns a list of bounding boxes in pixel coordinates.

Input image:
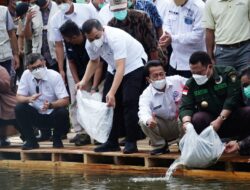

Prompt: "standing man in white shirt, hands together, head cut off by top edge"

[159,0,205,78]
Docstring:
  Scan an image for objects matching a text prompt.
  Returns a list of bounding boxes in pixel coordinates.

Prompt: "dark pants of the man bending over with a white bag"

[103,67,144,143]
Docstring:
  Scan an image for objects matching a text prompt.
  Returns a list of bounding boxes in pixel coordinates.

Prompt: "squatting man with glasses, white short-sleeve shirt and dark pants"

[15,53,69,150]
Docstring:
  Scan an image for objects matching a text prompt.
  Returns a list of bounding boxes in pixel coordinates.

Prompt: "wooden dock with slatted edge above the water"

[0,138,250,180]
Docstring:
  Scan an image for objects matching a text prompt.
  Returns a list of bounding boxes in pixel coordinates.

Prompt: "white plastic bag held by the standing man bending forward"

[76,90,113,143]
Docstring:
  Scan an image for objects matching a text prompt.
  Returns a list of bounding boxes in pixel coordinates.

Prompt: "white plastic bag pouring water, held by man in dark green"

[179,124,225,168]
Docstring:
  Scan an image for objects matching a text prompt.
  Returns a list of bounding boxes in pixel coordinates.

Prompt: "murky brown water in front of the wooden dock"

[0,168,250,190]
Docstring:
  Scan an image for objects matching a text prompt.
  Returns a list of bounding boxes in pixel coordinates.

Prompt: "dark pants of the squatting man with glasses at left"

[15,103,69,141]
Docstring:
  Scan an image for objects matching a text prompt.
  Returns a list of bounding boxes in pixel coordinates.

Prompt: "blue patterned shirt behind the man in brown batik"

[134,0,163,28]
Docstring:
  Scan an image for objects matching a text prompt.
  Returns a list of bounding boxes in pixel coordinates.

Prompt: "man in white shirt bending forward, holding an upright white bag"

[77,19,147,154]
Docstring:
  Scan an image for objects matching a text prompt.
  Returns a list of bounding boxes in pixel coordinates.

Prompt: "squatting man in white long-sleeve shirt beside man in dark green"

[138,60,187,155]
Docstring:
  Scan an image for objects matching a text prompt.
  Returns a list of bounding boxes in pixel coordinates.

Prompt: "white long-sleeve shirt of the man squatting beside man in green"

[138,75,187,125]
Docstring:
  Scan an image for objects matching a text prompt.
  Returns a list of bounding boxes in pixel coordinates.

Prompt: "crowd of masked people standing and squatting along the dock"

[0,0,250,155]
